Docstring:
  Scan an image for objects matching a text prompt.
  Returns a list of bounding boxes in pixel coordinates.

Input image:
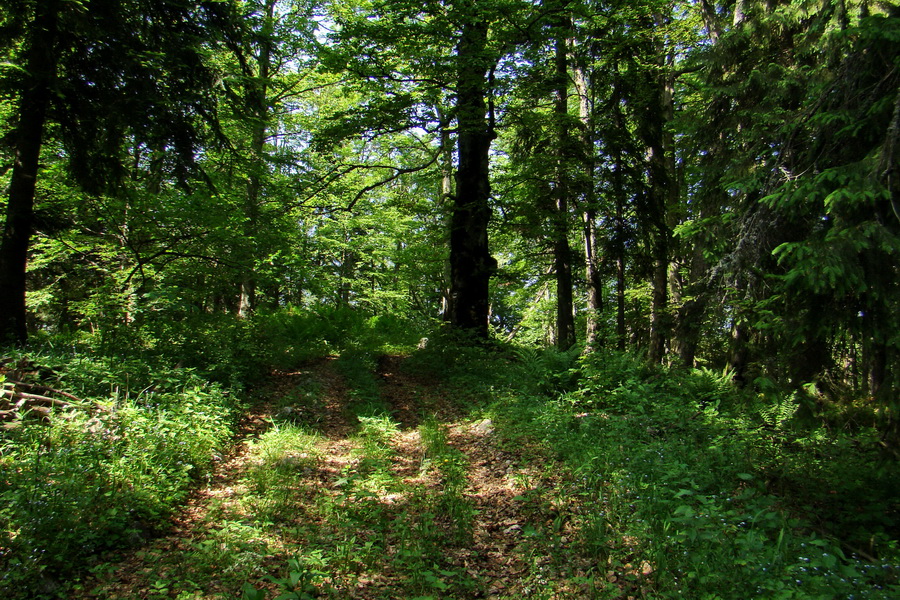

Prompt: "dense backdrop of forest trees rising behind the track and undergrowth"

[0,0,900,597]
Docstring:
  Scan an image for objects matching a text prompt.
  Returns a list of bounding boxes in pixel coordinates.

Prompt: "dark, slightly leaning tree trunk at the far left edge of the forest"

[0,0,59,345]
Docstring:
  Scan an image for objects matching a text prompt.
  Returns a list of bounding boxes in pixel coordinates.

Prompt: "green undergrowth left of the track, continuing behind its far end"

[0,308,418,599]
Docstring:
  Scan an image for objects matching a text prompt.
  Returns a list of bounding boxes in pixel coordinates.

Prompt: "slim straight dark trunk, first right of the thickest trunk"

[553,28,575,350]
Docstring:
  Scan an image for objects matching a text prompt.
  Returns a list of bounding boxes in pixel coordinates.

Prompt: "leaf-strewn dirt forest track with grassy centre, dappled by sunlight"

[73,356,631,600]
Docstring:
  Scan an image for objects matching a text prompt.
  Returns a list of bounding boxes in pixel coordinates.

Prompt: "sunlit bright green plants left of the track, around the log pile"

[0,355,239,600]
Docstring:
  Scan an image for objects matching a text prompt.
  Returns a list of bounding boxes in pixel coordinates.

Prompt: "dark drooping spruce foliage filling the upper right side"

[676,2,900,406]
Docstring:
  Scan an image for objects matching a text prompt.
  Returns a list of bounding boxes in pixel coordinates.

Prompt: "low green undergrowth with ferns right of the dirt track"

[495,346,900,598]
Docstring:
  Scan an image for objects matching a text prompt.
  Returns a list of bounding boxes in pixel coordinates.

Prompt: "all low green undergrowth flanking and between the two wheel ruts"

[0,310,900,600]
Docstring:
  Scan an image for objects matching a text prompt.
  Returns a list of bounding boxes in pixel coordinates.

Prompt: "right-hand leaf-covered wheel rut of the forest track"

[370,356,592,598]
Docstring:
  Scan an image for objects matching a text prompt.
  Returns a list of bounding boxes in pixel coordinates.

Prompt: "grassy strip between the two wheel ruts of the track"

[240,349,482,600]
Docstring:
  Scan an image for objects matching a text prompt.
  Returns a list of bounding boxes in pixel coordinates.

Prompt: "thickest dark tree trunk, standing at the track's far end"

[450,5,497,338]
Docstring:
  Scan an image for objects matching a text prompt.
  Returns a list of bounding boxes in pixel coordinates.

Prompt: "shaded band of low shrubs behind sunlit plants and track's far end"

[23,308,427,393]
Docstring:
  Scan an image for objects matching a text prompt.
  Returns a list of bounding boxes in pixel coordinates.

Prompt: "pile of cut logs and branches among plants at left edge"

[0,358,90,429]
